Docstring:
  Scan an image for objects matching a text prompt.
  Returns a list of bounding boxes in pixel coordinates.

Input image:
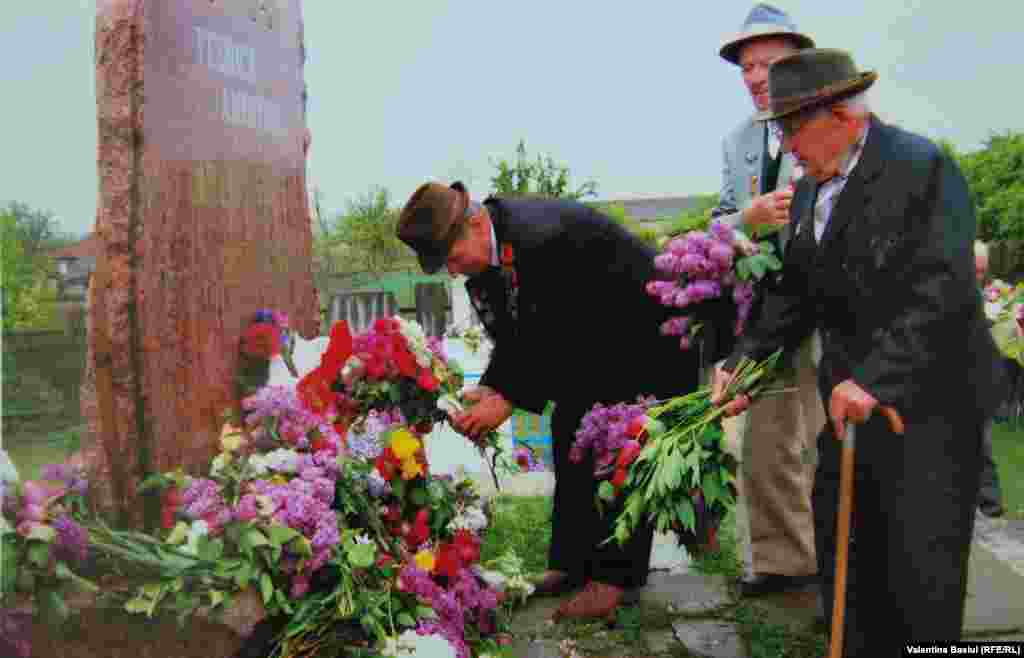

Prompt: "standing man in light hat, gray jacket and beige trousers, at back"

[713,4,825,597]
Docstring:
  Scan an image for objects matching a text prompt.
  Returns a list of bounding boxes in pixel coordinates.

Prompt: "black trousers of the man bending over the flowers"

[548,402,654,588]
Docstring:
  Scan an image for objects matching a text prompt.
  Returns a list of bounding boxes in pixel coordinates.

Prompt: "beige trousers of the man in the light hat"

[730,334,825,576]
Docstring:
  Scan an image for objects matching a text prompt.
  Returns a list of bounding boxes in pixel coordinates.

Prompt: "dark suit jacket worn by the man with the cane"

[727,118,1001,418]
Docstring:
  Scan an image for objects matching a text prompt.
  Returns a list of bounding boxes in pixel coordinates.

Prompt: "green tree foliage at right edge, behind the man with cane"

[939,132,1024,242]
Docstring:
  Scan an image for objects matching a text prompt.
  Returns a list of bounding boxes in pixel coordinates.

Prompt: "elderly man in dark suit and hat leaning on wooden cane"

[714,49,1001,658]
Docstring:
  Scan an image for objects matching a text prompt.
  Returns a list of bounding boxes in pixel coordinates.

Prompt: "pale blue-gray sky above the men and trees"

[0,0,1024,234]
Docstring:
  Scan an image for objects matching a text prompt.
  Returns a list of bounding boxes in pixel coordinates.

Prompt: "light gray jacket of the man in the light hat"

[715,118,797,248]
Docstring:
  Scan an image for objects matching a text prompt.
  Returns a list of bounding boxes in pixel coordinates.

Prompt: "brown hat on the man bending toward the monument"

[397,181,469,274]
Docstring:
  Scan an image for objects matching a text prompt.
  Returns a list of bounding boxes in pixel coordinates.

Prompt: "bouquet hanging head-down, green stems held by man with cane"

[569,352,781,554]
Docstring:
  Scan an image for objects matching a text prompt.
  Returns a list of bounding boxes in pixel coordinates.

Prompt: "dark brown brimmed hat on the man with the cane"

[754,48,879,121]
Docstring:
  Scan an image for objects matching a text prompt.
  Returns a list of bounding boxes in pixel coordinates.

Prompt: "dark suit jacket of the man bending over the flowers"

[467,198,697,412]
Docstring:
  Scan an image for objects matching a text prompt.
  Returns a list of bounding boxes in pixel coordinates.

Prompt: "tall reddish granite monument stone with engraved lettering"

[84,0,318,520]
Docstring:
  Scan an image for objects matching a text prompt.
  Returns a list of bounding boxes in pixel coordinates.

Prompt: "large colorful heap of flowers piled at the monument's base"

[0,311,532,658]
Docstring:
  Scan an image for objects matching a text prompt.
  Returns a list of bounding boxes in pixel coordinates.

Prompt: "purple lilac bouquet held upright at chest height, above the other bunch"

[646,221,782,350]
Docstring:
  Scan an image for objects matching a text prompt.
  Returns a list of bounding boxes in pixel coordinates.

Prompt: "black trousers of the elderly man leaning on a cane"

[812,409,984,658]
